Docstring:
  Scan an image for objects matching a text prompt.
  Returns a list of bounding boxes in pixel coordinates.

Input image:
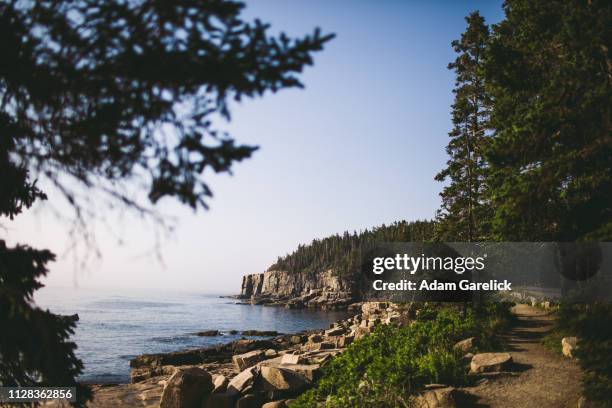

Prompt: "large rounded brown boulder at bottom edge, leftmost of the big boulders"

[159,367,214,408]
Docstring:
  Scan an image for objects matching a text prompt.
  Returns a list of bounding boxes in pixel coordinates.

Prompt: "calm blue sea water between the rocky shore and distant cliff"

[35,288,346,383]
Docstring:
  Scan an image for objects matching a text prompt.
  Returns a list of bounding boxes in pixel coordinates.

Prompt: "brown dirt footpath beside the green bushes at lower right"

[461,304,582,408]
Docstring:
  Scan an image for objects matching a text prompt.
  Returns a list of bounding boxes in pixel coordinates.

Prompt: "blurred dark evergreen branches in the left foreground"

[0,0,332,400]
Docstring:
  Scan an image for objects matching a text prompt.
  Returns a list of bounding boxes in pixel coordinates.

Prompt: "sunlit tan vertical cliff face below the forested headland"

[240,269,356,308]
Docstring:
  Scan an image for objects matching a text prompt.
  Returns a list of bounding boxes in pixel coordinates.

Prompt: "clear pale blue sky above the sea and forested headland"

[0,0,503,294]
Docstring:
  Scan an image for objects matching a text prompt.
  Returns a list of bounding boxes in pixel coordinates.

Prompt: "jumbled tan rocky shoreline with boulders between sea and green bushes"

[69,302,394,408]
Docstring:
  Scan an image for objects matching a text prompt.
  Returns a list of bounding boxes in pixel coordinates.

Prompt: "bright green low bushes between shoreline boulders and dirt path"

[291,304,509,408]
